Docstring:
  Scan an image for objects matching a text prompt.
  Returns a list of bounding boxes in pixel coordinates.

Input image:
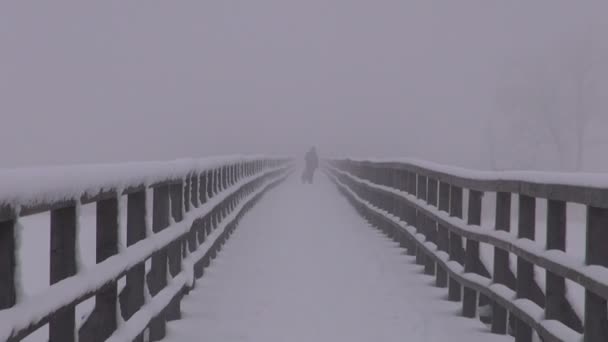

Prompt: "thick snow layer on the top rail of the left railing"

[0,156,276,210]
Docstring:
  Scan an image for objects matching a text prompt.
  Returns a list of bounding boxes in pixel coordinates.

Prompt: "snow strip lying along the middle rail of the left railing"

[0,167,281,340]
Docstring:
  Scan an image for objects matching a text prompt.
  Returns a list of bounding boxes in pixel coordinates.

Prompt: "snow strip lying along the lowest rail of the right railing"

[330,168,582,341]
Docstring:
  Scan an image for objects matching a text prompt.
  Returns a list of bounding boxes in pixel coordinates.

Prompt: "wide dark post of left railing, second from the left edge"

[49,203,78,342]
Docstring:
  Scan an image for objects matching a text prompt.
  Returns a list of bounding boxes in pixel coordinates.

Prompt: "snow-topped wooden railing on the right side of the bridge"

[325,160,608,342]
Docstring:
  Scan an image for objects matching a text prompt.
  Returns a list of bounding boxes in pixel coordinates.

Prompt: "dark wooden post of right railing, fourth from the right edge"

[492,192,511,334]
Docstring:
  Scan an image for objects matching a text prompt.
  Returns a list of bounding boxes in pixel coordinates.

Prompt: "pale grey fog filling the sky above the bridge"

[0,0,608,171]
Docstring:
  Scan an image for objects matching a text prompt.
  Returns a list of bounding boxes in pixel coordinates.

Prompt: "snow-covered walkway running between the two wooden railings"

[168,174,512,342]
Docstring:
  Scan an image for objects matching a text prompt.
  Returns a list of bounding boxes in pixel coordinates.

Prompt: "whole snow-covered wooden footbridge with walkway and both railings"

[0,157,608,342]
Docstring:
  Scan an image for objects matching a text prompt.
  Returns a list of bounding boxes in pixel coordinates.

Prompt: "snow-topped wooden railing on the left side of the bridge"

[0,158,291,342]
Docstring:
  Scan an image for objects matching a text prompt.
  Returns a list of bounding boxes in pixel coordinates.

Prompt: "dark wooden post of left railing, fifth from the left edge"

[148,184,170,341]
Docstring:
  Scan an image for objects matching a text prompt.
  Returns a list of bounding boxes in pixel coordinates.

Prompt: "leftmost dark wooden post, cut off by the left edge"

[0,212,17,310]
